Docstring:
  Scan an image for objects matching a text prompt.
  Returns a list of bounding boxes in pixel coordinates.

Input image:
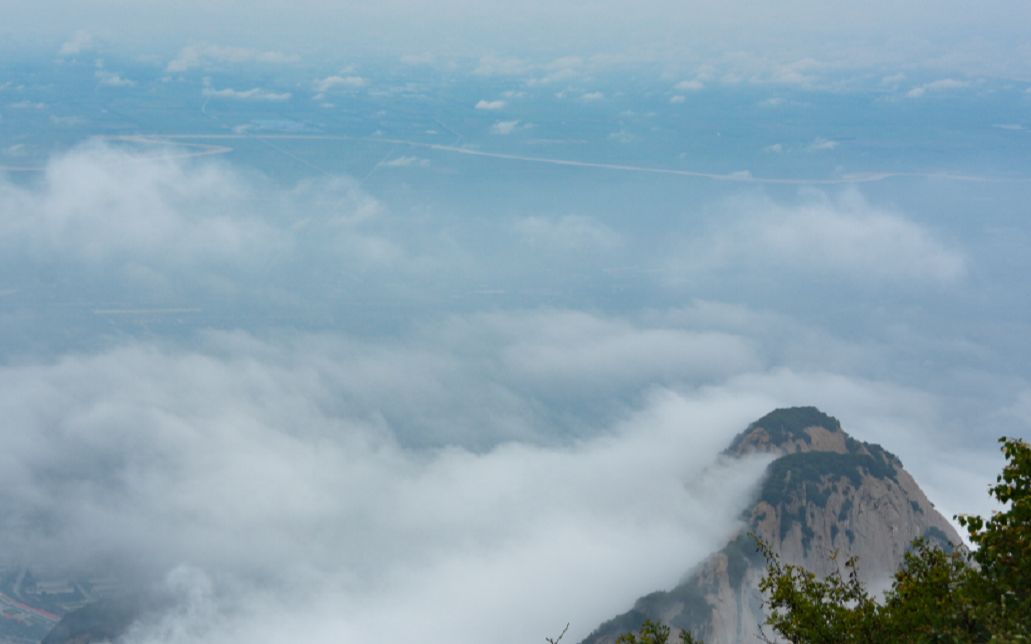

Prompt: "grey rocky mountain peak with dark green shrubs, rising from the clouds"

[585,407,960,644]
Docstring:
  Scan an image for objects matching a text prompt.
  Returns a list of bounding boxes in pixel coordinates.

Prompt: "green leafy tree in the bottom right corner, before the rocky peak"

[759,438,1031,643]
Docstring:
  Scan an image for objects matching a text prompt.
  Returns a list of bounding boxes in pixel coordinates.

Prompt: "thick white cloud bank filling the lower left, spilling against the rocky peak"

[0,319,779,642]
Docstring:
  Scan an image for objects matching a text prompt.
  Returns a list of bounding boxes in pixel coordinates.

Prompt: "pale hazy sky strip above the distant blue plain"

[6,0,1031,78]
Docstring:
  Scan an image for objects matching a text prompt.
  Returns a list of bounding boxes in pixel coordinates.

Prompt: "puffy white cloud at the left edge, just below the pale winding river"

[0,143,405,280]
